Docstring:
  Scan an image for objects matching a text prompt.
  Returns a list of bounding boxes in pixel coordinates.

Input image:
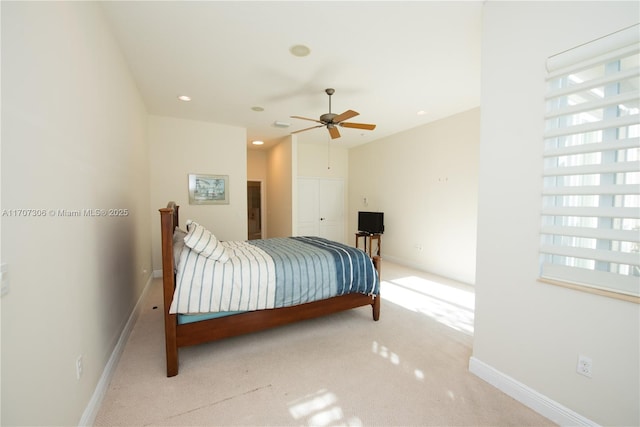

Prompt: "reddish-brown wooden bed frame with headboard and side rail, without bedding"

[160,202,380,377]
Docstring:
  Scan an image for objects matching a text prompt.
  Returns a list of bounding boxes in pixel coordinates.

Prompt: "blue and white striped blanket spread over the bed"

[169,237,380,314]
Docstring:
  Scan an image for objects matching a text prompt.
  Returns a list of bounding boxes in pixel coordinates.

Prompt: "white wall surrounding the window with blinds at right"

[472,2,640,426]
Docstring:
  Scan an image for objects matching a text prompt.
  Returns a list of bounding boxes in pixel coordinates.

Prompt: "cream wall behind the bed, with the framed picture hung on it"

[149,115,248,270]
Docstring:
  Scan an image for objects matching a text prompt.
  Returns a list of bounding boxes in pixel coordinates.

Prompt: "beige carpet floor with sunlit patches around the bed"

[95,261,553,426]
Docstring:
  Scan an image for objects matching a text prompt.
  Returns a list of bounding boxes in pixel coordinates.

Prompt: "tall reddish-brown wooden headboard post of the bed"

[160,202,178,377]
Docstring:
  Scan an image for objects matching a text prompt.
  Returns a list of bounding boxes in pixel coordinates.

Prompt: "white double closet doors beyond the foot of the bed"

[298,178,344,243]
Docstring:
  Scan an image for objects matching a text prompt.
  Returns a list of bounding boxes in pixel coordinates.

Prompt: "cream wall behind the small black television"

[349,109,480,284]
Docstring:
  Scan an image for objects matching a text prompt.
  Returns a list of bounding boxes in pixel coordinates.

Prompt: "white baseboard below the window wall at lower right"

[469,356,599,427]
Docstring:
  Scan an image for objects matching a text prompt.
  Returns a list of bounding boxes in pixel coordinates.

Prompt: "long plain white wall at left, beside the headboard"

[1,2,151,425]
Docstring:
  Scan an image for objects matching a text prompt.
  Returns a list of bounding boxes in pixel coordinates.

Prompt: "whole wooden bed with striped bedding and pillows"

[160,202,380,377]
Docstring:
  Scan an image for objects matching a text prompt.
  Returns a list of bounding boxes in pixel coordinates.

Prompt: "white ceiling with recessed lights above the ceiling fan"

[102,1,482,147]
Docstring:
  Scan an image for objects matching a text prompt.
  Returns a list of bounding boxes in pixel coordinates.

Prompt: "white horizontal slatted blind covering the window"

[540,25,640,297]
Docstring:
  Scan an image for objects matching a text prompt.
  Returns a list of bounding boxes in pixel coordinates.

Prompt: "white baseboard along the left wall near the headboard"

[78,272,155,426]
